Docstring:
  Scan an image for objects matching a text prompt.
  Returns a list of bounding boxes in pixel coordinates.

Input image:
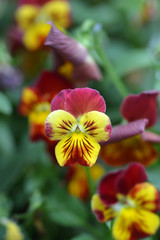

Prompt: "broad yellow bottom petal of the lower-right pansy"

[113,208,160,240]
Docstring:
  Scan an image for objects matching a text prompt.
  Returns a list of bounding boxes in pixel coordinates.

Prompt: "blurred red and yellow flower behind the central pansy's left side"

[19,71,71,140]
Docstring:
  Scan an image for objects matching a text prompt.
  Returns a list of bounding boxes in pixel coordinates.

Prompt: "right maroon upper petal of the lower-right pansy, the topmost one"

[116,163,147,195]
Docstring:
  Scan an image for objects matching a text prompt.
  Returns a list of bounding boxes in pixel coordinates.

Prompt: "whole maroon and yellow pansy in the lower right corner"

[91,163,160,240]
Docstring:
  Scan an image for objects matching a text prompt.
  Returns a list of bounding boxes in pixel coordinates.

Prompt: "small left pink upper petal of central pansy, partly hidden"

[51,89,72,111]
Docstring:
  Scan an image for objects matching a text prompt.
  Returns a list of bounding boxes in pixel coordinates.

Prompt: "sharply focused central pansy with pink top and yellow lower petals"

[45,88,111,167]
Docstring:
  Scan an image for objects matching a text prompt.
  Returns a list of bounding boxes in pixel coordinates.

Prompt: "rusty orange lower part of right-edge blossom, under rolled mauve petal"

[100,134,158,166]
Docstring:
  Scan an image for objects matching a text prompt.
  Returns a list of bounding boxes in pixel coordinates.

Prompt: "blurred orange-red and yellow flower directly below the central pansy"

[67,163,105,201]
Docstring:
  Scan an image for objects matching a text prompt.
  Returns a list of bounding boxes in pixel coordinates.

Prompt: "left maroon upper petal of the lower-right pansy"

[98,170,124,205]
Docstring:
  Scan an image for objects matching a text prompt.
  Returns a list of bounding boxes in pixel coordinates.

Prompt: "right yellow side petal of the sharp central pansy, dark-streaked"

[79,111,111,142]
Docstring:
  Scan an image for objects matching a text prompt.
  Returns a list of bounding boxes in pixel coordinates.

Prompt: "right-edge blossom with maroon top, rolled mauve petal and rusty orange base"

[100,90,160,166]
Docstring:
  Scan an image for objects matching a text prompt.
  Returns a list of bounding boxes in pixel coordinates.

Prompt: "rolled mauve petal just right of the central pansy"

[103,119,148,145]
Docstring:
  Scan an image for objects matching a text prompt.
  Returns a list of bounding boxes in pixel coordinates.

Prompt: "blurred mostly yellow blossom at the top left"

[15,0,71,51]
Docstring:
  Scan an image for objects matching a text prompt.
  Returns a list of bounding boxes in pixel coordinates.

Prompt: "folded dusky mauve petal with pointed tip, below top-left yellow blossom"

[45,23,88,65]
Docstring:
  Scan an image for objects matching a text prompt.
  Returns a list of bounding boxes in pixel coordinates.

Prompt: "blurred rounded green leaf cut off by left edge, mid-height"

[0,92,12,115]
